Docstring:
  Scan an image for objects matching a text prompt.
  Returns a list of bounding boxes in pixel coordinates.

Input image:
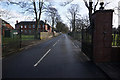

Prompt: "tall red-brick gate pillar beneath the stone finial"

[92,10,113,62]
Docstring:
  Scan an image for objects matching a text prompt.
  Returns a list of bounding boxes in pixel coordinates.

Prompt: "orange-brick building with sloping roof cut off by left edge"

[1,19,14,37]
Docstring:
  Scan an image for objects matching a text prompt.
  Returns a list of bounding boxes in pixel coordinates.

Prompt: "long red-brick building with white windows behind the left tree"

[15,21,51,35]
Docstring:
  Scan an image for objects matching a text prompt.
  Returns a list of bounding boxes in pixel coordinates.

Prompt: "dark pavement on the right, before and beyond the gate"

[69,36,120,80]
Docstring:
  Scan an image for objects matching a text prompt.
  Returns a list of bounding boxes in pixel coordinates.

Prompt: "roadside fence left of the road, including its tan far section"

[2,30,55,56]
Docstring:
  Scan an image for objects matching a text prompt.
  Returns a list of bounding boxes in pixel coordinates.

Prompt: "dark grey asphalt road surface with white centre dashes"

[2,34,109,80]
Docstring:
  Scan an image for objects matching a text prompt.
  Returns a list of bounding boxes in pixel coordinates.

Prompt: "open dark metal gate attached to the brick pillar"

[82,26,93,60]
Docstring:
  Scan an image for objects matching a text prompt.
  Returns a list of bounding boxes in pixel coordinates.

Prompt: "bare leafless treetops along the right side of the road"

[62,0,110,32]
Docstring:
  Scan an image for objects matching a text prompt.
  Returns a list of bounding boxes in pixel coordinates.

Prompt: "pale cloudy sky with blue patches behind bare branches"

[0,0,120,27]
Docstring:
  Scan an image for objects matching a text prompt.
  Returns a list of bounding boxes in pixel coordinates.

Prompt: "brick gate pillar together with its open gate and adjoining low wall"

[82,10,120,62]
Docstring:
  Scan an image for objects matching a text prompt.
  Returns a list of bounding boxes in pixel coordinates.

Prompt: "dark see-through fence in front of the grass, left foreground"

[2,30,34,56]
